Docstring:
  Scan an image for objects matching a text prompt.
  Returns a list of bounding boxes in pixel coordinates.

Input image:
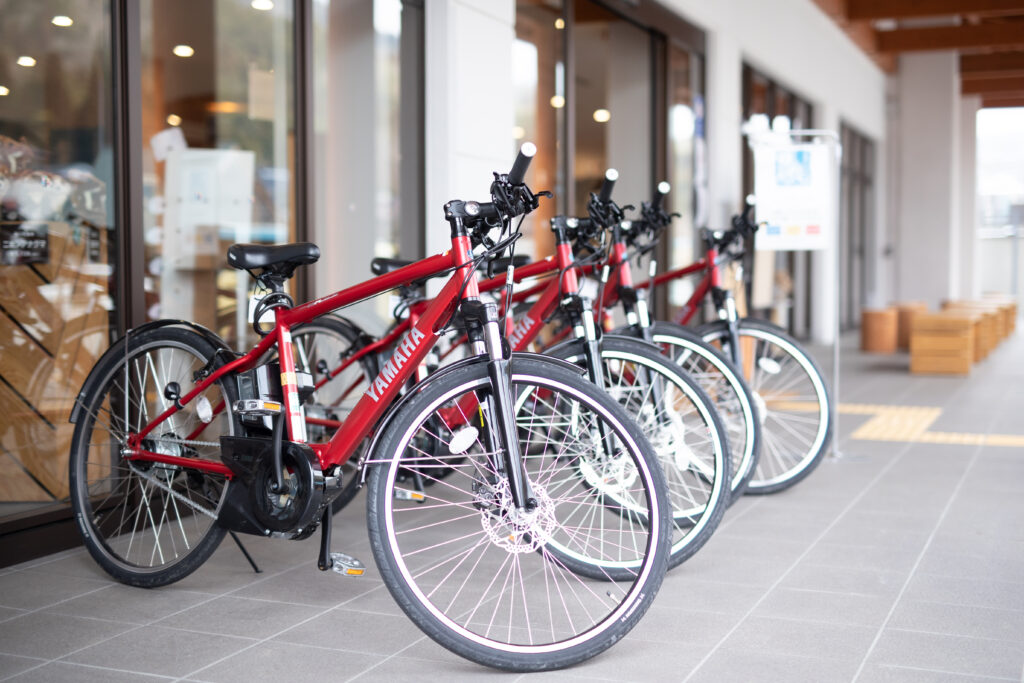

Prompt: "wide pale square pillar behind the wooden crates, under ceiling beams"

[895,51,961,306]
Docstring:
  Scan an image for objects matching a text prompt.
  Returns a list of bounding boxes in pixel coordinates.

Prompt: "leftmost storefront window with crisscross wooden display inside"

[0,0,118,519]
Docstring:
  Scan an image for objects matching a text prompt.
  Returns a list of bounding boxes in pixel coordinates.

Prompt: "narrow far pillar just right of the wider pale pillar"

[957,95,981,299]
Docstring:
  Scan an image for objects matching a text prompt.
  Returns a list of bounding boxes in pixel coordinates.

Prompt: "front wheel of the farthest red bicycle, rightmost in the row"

[698,319,831,494]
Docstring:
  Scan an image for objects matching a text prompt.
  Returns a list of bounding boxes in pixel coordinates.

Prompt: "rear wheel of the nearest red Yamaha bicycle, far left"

[69,327,238,588]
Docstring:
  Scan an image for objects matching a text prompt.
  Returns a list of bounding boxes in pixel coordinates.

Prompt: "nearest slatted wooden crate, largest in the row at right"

[910,311,981,375]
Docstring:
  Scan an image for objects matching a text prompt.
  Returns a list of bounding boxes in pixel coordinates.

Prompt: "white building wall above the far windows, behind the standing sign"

[665,0,888,343]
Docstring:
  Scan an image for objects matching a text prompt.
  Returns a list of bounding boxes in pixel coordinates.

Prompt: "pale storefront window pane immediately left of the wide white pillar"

[312,0,423,330]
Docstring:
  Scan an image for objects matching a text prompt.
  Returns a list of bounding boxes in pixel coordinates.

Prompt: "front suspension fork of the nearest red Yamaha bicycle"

[462,299,537,510]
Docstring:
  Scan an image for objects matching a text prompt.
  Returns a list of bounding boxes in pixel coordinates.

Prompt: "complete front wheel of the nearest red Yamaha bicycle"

[367,355,670,671]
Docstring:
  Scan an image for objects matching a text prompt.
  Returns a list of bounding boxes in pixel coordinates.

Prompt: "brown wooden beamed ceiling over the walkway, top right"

[814,0,1024,108]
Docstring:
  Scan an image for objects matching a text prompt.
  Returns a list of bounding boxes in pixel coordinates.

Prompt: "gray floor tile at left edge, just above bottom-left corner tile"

[0,612,133,659]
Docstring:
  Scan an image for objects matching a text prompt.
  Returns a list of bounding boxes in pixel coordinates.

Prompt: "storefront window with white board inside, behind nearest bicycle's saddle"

[140,0,296,346]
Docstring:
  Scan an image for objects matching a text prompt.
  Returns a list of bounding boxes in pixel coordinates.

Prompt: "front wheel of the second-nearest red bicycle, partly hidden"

[547,335,731,567]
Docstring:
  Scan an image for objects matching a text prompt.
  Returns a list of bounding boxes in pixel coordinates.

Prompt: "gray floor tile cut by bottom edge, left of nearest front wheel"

[186,642,382,683]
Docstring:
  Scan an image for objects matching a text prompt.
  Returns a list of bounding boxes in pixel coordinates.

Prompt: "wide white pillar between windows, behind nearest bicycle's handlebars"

[424,0,515,262]
